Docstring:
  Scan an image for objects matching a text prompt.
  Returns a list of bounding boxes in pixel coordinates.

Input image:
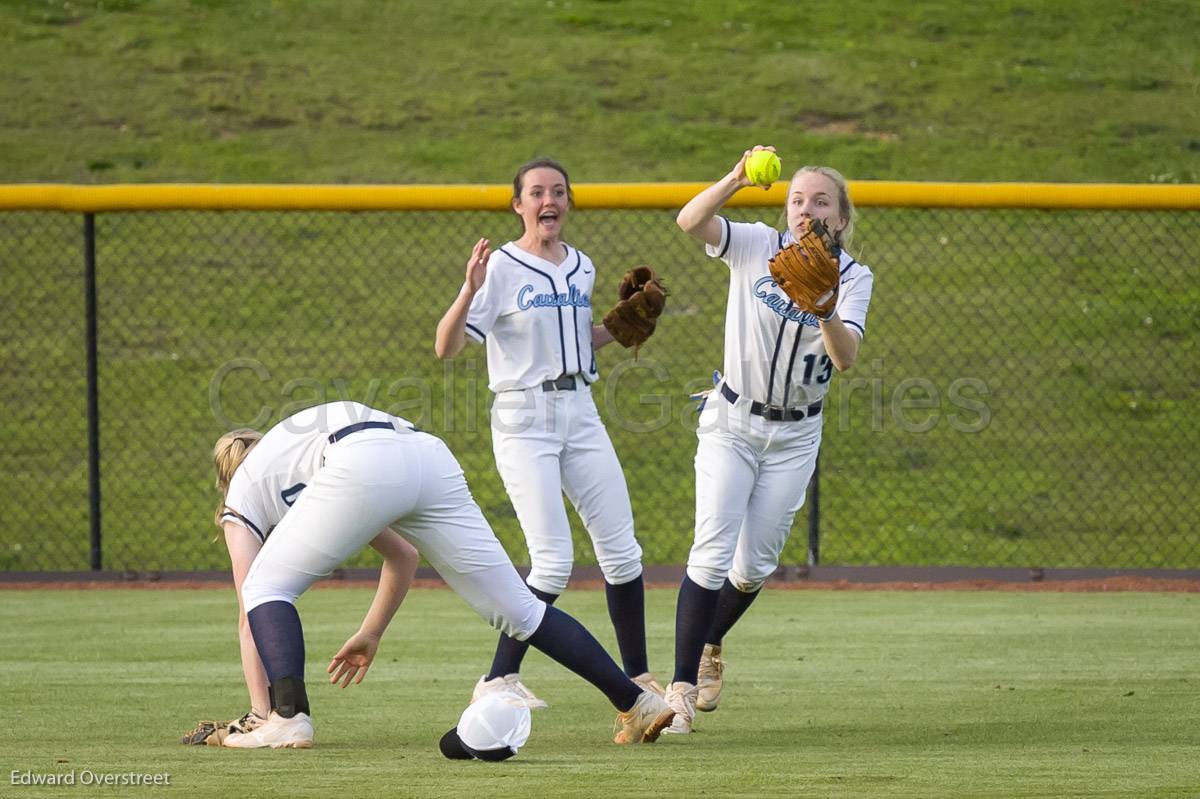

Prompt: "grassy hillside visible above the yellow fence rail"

[0,0,1200,182]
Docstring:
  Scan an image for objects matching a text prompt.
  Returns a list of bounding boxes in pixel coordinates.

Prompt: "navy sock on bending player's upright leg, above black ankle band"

[246,600,311,719]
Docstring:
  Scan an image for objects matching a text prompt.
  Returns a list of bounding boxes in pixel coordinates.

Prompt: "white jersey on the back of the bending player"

[221,402,413,541]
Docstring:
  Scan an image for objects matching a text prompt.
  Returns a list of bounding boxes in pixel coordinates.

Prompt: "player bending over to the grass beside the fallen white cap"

[214,402,674,749]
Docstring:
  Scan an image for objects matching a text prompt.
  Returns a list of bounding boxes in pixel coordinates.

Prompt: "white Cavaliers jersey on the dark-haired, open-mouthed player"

[467,241,599,392]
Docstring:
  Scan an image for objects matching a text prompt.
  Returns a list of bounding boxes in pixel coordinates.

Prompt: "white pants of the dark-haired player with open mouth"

[492,385,642,594]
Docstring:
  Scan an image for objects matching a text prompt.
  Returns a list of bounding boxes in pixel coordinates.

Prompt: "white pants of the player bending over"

[242,431,546,641]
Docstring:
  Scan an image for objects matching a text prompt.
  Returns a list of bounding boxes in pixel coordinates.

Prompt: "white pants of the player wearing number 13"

[688,383,823,591]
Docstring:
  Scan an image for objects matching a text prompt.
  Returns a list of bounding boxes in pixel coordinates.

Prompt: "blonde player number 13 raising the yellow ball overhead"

[666,146,874,733]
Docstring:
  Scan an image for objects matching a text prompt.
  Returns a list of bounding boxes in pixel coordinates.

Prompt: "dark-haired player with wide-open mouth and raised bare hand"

[436,160,662,708]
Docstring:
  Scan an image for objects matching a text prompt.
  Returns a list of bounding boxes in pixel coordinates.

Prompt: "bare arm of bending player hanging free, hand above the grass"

[325,528,420,687]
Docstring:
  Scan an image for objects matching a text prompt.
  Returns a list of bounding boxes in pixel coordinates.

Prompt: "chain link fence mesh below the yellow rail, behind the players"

[0,199,1200,571]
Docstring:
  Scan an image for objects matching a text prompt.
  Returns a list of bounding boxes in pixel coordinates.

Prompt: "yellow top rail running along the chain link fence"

[0,180,1200,212]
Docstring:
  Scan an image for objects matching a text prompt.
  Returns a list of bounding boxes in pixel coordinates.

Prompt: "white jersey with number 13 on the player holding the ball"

[706,217,874,408]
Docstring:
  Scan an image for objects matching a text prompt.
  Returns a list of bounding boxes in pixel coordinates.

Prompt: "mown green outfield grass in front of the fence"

[0,589,1200,799]
